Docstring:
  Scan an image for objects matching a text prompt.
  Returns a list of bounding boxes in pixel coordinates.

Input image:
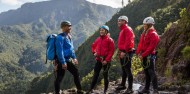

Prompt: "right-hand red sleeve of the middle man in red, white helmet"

[124,29,134,52]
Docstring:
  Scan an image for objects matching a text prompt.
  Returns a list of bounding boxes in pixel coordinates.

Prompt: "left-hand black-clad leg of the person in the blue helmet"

[90,61,102,90]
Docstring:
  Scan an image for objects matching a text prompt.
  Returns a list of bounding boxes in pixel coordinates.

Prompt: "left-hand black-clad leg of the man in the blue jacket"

[54,63,65,94]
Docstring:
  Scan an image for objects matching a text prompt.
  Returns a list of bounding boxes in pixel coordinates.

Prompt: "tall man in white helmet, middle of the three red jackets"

[116,16,135,93]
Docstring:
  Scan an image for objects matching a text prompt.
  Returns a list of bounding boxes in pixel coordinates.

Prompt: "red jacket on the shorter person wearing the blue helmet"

[92,35,115,62]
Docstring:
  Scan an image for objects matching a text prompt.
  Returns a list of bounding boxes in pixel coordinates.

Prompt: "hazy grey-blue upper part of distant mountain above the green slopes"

[0,0,117,48]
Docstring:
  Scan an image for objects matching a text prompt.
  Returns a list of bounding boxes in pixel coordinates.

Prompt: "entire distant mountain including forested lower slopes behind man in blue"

[0,0,117,94]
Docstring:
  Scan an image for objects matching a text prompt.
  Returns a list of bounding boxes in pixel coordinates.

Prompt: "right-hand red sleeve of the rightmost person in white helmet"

[142,33,159,57]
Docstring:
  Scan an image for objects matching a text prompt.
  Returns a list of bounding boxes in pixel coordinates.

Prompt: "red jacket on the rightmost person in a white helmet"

[136,28,160,57]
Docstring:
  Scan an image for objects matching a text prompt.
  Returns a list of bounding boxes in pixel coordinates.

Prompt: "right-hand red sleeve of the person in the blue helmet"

[105,39,115,62]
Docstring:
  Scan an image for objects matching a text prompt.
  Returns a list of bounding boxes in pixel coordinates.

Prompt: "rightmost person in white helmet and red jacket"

[136,17,160,94]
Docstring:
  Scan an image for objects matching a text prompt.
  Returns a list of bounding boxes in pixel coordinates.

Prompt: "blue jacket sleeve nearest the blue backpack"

[55,36,66,64]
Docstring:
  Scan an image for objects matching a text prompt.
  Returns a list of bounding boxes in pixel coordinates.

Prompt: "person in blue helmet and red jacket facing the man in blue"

[88,25,115,93]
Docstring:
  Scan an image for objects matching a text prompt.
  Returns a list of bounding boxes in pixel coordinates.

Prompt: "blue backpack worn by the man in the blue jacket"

[45,34,57,64]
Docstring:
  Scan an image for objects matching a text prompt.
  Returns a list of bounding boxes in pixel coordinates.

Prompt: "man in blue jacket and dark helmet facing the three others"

[54,21,83,94]
